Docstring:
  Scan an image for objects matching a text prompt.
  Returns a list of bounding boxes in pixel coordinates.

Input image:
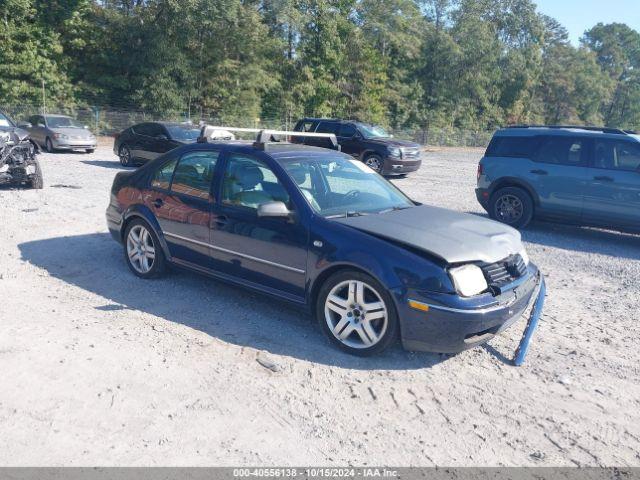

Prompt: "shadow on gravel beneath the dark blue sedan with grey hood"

[19,233,449,370]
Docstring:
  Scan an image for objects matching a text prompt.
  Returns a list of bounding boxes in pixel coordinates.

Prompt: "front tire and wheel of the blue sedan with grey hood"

[316,270,399,357]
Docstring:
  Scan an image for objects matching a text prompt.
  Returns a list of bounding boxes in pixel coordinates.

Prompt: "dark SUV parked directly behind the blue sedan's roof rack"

[292,118,422,175]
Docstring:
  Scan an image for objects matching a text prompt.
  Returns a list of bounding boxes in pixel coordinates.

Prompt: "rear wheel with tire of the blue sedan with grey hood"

[124,219,166,279]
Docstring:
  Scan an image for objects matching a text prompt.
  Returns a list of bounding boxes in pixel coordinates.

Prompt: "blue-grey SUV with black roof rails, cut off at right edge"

[476,126,640,231]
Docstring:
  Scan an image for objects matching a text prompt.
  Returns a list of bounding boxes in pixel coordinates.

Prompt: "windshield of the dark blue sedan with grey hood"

[281,157,414,217]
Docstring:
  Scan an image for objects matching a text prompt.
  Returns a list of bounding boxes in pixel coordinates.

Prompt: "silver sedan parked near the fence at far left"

[27,115,97,153]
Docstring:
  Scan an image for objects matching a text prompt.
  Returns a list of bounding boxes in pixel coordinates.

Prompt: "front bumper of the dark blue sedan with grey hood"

[394,265,544,353]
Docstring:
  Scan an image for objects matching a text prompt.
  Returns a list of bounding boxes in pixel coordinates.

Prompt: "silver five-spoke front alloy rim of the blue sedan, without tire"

[324,280,389,349]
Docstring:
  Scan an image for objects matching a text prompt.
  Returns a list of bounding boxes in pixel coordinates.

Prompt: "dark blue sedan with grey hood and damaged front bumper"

[106,131,544,355]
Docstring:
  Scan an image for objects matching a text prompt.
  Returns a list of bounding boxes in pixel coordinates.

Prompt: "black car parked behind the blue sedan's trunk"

[113,122,205,167]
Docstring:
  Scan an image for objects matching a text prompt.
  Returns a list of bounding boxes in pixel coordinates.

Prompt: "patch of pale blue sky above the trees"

[534,0,640,45]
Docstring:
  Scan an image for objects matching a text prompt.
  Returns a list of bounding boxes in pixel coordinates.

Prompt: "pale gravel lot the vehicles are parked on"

[0,143,640,466]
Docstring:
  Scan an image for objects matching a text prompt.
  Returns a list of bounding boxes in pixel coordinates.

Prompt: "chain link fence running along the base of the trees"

[3,104,493,148]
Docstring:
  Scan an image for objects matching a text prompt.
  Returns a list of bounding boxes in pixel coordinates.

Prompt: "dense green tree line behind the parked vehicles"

[0,0,640,135]
